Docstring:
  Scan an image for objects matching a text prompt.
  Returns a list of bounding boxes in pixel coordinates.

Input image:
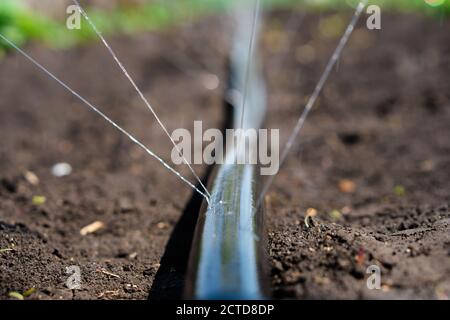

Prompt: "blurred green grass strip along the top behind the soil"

[0,0,450,54]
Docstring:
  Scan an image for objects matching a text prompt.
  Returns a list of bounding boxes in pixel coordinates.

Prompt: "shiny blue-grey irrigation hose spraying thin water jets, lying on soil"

[185,3,267,299]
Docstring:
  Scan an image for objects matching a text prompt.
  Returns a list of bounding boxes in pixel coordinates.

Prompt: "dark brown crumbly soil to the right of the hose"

[267,11,450,299]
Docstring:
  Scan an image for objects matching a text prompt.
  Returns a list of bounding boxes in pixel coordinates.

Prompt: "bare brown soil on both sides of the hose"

[0,11,450,299]
